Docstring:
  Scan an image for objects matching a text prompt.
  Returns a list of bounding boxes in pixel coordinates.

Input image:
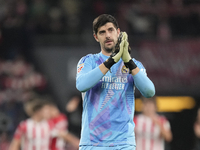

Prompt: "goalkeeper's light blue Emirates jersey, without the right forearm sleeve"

[76,53,146,146]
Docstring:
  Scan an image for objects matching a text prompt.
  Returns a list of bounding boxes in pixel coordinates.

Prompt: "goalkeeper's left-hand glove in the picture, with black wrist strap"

[104,33,125,69]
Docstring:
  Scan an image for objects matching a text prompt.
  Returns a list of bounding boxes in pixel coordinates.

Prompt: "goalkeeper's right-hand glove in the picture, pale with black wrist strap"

[122,32,137,71]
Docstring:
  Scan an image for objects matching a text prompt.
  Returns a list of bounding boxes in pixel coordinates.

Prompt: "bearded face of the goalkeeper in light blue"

[94,22,120,53]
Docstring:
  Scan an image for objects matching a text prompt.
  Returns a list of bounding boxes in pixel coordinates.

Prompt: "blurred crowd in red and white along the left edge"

[0,56,46,148]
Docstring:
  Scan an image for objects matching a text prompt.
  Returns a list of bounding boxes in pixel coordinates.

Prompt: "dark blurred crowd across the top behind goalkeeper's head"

[0,0,200,38]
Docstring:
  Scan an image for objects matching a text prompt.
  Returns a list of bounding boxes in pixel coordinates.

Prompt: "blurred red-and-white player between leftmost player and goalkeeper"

[43,100,79,150]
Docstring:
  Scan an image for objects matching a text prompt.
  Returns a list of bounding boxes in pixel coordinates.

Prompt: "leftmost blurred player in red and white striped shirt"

[9,99,52,150]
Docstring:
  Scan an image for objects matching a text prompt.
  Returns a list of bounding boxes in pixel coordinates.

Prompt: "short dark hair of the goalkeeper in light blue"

[93,14,119,34]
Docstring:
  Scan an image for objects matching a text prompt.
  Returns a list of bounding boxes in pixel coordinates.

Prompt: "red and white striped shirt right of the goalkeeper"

[134,114,170,150]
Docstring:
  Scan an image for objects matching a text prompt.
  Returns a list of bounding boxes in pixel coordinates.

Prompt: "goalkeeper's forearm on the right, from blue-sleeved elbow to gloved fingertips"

[122,32,155,98]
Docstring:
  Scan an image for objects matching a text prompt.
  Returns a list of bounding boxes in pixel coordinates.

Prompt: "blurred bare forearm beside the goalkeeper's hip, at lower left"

[58,132,80,149]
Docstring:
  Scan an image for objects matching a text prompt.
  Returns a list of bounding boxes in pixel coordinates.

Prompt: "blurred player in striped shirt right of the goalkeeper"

[134,96,172,150]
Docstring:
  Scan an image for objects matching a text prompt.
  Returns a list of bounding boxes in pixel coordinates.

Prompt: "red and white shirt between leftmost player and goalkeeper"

[50,114,68,150]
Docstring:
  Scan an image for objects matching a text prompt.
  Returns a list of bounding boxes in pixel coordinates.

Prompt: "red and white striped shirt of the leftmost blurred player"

[14,118,53,150]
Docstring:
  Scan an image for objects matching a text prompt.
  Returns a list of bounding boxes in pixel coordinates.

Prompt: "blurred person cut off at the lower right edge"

[194,108,200,150]
